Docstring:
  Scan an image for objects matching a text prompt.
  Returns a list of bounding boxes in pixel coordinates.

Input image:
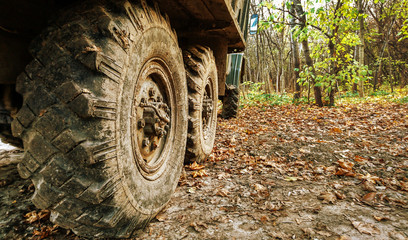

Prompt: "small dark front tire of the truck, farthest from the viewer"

[221,85,239,119]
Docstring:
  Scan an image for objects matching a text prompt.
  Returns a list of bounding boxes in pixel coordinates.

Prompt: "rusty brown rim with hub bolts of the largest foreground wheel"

[131,59,175,180]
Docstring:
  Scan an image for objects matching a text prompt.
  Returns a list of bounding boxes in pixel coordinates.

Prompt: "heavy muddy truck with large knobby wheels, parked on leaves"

[0,0,249,238]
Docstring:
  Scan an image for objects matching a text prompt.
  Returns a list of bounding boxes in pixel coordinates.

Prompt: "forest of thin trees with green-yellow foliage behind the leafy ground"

[242,0,408,106]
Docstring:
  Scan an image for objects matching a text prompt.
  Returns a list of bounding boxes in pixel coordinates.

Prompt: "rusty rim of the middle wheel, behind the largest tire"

[201,78,215,140]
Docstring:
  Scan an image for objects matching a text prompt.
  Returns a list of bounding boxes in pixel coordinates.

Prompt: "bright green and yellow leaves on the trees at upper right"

[253,0,408,102]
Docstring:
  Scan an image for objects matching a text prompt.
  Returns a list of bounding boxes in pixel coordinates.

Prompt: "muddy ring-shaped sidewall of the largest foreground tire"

[116,26,187,215]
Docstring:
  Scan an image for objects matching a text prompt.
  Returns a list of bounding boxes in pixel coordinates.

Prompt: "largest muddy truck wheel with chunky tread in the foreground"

[12,0,188,238]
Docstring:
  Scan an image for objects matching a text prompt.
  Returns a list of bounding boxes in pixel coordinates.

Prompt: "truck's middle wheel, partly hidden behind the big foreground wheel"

[183,46,218,163]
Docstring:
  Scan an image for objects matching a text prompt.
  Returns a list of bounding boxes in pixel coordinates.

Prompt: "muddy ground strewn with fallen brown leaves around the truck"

[0,104,408,239]
